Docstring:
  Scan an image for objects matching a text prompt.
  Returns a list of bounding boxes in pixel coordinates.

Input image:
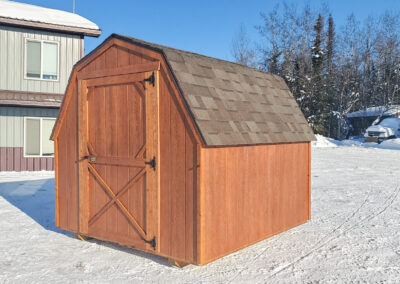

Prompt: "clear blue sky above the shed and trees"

[12,0,400,61]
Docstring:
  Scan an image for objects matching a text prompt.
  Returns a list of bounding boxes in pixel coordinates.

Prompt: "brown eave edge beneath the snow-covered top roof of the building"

[0,17,101,37]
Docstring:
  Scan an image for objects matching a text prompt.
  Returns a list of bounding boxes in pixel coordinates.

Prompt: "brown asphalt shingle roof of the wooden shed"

[112,34,315,146]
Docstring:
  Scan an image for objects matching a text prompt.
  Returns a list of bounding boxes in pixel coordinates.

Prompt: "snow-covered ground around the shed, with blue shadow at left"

[0,145,400,283]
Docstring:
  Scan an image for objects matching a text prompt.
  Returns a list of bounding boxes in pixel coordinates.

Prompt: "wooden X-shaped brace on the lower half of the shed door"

[88,163,156,250]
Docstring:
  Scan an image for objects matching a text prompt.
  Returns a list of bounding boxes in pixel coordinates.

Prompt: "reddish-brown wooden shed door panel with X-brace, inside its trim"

[88,78,149,249]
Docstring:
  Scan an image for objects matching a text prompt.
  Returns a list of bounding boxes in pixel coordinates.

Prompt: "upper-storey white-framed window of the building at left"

[25,39,58,80]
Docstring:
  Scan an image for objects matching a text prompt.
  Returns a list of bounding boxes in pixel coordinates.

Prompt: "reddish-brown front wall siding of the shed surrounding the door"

[57,42,197,262]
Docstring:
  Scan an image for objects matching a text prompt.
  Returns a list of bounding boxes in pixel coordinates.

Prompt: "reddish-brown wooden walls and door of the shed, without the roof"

[53,39,311,264]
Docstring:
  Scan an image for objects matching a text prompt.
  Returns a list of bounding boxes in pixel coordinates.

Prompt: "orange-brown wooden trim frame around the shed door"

[76,69,161,253]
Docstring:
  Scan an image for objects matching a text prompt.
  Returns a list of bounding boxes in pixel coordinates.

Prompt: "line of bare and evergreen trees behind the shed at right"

[232,3,400,139]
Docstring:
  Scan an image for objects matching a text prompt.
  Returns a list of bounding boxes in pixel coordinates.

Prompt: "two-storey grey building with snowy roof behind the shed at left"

[0,0,101,171]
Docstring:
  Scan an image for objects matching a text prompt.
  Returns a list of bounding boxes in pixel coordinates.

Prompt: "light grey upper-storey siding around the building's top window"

[0,26,83,94]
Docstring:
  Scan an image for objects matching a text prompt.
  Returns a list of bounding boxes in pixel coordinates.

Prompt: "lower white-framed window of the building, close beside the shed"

[24,117,56,157]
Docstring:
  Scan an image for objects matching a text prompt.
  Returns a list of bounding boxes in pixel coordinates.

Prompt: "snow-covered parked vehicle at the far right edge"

[364,117,400,143]
